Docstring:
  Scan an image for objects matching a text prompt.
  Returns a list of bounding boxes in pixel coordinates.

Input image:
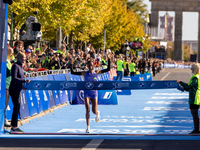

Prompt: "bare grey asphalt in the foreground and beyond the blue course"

[0,68,200,150]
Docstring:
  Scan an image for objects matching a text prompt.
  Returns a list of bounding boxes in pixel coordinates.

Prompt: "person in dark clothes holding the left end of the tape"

[9,52,30,133]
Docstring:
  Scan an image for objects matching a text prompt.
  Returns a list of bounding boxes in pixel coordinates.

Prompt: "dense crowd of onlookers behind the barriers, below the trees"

[8,41,193,76]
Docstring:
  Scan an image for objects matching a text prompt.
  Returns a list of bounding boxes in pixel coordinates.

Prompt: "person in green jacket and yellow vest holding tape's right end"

[176,63,200,134]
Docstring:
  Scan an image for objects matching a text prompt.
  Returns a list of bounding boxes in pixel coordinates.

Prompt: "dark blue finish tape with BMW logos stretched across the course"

[25,80,179,90]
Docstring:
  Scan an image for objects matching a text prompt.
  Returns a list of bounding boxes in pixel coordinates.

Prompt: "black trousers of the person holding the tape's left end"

[9,88,21,127]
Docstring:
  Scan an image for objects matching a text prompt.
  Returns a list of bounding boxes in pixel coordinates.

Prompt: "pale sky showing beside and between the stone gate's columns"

[143,0,198,40]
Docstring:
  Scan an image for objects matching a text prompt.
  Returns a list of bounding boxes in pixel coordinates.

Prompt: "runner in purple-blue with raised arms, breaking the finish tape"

[70,58,110,133]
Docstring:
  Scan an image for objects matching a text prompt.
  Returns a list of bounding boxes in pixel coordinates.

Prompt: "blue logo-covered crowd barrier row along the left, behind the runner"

[6,70,118,120]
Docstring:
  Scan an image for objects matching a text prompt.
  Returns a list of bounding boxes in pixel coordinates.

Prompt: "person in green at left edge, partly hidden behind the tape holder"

[4,47,13,127]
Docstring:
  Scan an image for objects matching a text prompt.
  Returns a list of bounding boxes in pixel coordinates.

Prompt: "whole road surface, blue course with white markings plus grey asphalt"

[0,68,200,150]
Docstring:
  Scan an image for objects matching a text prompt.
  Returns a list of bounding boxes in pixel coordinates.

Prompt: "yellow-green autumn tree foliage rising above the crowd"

[9,0,148,49]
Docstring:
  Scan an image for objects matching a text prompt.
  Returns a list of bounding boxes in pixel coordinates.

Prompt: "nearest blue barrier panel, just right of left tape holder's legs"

[20,90,30,119]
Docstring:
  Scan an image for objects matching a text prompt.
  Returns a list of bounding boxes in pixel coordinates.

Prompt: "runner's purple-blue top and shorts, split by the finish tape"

[84,71,97,98]
